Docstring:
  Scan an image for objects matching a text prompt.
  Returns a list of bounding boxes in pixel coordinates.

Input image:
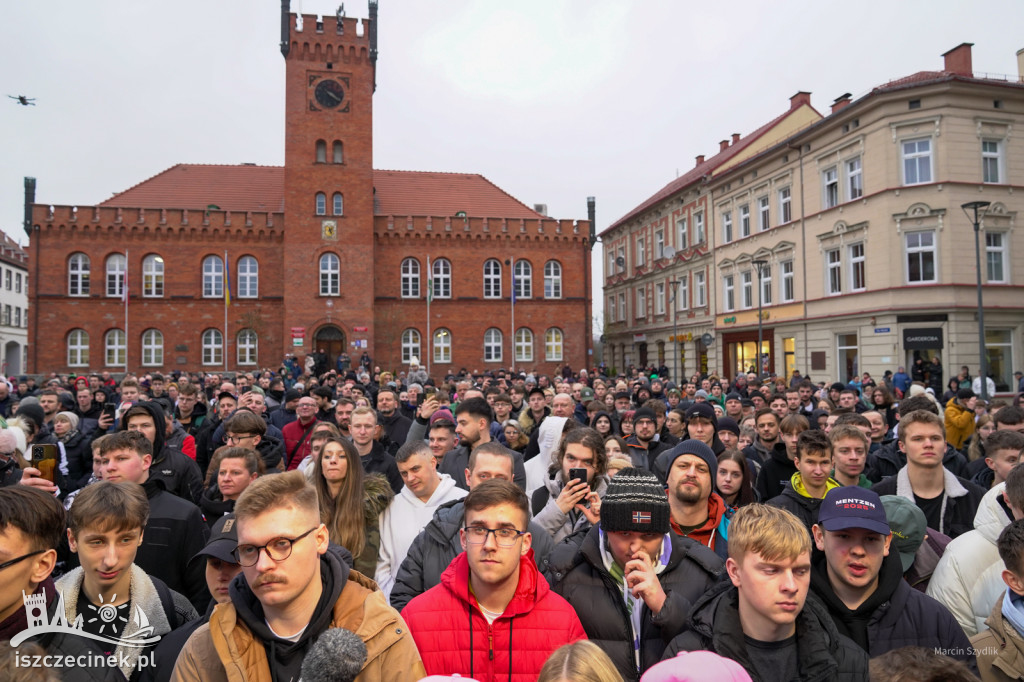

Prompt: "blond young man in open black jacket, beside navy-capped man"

[663,504,867,682]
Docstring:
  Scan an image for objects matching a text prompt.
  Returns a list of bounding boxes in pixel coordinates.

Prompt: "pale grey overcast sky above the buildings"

[0,0,1024,329]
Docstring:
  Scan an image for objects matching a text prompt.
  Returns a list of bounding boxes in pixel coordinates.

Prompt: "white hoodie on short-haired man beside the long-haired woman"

[374,474,466,599]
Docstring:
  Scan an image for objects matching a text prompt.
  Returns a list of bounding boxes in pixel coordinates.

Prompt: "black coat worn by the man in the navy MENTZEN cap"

[811,551,976,667]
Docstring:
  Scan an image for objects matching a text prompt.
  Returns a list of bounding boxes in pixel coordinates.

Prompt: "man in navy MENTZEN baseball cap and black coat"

[811,485,976,668]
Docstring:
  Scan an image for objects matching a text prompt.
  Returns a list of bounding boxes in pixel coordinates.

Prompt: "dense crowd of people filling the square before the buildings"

[0,354,1024,682]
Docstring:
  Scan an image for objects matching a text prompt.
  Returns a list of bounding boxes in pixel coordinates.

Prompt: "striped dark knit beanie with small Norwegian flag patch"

[601,467,672,535]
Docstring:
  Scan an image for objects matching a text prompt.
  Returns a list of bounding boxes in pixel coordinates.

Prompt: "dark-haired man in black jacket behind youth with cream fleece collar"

[95,430,210,613]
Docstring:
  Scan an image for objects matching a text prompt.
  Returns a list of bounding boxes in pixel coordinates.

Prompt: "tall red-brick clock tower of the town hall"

[281,0,377,368]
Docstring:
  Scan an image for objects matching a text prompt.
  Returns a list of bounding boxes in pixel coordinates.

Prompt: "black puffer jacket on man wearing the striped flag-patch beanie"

[547,527,724,681]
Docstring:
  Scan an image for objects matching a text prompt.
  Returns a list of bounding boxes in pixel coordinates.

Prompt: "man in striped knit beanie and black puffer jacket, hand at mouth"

[548,468,723,680]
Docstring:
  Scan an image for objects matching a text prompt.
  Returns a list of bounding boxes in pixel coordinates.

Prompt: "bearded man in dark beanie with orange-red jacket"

[657,439,733,560]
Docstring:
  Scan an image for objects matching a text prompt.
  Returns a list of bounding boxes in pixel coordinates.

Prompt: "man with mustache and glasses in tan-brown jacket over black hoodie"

[171,471,424,682]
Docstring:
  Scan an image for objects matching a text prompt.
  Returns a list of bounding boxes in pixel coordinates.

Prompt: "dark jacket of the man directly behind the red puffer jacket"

[391,493,555,611]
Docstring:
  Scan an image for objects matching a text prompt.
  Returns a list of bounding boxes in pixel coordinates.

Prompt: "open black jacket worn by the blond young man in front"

[664,581,868,682]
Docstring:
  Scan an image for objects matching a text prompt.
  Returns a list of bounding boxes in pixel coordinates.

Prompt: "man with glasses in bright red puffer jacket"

[401,479,587,682]
